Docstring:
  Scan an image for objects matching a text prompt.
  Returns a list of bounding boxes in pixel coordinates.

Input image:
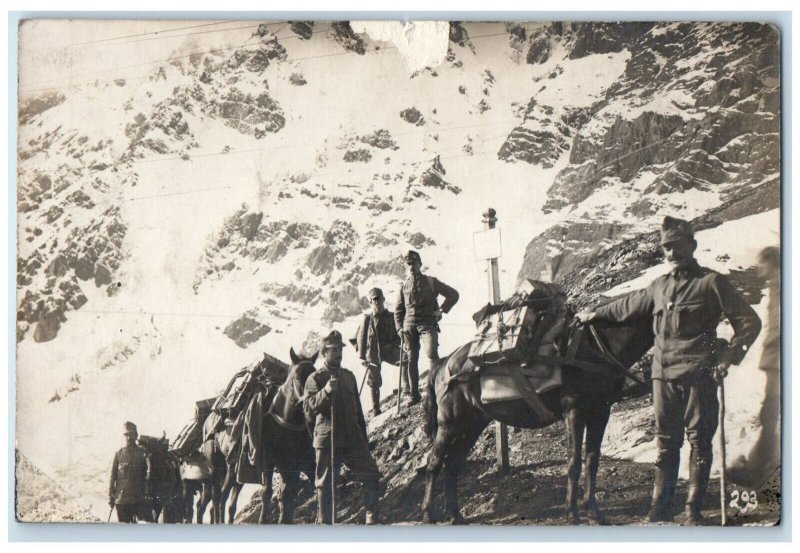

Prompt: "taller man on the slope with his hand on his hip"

[394,250,458,404]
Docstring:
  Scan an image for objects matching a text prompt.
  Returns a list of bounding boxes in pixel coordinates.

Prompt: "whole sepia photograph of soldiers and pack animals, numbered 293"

[13,19,788,528]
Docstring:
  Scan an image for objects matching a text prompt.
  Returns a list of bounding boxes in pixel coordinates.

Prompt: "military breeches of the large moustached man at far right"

[653,373,719,464]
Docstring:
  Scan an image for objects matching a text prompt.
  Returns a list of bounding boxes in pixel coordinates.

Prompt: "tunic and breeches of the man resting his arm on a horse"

[595,262,761,454]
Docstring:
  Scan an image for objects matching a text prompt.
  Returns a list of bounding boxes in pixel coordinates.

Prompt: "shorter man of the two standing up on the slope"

[356,288,402,415]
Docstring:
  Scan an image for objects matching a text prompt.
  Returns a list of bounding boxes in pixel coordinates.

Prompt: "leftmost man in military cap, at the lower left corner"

[108,422,150,523]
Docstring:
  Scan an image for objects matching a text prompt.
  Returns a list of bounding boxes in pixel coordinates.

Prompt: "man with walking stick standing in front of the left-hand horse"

[303,330,381,524]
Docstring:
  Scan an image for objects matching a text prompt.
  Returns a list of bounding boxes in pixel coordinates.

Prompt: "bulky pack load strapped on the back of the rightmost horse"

[462,280,570,418]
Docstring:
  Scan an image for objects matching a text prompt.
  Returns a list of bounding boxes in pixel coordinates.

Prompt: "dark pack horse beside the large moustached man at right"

[422,321,653,524]
